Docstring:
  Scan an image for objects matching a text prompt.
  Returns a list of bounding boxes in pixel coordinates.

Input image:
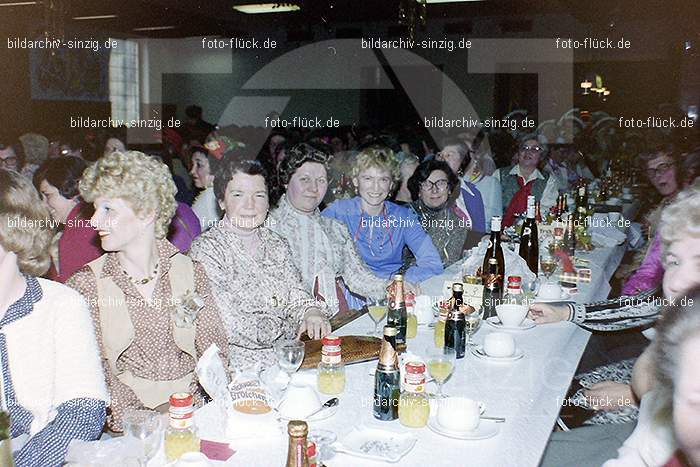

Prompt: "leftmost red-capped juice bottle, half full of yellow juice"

[165,392,199,462]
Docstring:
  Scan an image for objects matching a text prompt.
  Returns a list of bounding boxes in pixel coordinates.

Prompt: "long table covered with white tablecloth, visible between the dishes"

[174,238,626,467]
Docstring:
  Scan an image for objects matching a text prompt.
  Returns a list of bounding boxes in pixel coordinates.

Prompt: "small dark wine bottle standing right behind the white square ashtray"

[373,326,401,421]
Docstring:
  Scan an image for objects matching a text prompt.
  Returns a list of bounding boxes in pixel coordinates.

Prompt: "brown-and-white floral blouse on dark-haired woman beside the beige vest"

[190,224,327,369]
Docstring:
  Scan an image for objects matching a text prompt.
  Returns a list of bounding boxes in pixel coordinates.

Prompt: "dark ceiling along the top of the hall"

[0,0,700,38]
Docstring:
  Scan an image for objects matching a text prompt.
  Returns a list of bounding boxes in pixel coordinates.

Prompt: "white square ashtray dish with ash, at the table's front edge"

[333,426,418,462]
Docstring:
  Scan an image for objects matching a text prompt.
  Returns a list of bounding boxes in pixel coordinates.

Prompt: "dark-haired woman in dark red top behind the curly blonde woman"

[34,156,104,282]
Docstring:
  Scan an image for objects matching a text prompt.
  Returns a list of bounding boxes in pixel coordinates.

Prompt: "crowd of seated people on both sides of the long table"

[0,119,700,467]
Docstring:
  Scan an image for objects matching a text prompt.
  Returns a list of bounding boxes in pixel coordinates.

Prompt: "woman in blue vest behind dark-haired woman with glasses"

[437,138,491,232]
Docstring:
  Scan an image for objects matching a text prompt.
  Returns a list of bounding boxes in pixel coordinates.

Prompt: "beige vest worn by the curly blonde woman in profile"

[88,253,197,408]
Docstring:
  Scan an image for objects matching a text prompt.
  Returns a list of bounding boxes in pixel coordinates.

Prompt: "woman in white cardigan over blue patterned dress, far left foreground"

[0,169,109,467]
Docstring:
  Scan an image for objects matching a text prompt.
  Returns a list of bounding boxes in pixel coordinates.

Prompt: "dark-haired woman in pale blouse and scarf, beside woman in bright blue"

[269,144,387,312]
